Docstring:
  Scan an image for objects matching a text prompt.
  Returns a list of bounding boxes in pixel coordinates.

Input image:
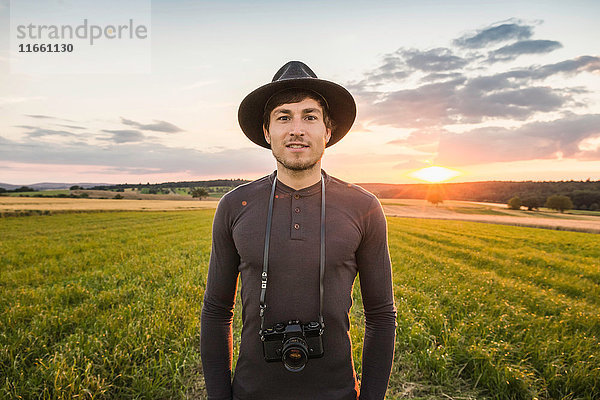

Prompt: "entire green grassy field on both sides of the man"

[0,210,600,399]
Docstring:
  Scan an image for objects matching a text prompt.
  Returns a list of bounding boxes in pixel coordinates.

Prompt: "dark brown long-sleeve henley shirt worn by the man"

[201,173,396,400]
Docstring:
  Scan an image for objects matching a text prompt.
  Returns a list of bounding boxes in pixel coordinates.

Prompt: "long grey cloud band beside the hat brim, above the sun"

[361,76,573,128]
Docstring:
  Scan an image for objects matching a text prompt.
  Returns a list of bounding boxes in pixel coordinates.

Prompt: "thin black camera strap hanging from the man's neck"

[259,174,325,338]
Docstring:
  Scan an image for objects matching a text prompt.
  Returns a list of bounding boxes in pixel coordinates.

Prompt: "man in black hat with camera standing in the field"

[201,61,396,400]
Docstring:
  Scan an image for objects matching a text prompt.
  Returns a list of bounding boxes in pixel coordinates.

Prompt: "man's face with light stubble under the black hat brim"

[263,98,331,171]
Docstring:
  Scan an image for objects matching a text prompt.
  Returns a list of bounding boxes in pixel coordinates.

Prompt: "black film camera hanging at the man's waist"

[261,320,324,372]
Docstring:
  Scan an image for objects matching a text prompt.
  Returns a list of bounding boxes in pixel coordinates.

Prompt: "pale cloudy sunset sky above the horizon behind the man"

[0,0,600,184]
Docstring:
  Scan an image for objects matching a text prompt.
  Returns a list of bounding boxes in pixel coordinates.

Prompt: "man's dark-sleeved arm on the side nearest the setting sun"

[356,199,396,400]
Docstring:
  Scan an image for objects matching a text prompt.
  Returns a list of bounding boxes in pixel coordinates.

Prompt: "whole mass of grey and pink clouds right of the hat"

[350,19,600,169]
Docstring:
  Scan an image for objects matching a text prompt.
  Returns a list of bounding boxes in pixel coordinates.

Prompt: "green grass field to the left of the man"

[0,210,214,399]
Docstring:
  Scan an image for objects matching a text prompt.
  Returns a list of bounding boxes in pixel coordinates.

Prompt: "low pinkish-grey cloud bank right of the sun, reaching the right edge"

[436,114,600,166]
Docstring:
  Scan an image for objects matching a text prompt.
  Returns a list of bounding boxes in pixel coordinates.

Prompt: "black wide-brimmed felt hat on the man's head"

[238,61,356,149]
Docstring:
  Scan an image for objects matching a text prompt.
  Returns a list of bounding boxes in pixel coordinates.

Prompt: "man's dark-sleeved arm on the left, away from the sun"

[200,197,240,400]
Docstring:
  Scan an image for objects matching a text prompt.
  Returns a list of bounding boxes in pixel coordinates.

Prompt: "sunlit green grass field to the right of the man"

[382,218,600,399]
